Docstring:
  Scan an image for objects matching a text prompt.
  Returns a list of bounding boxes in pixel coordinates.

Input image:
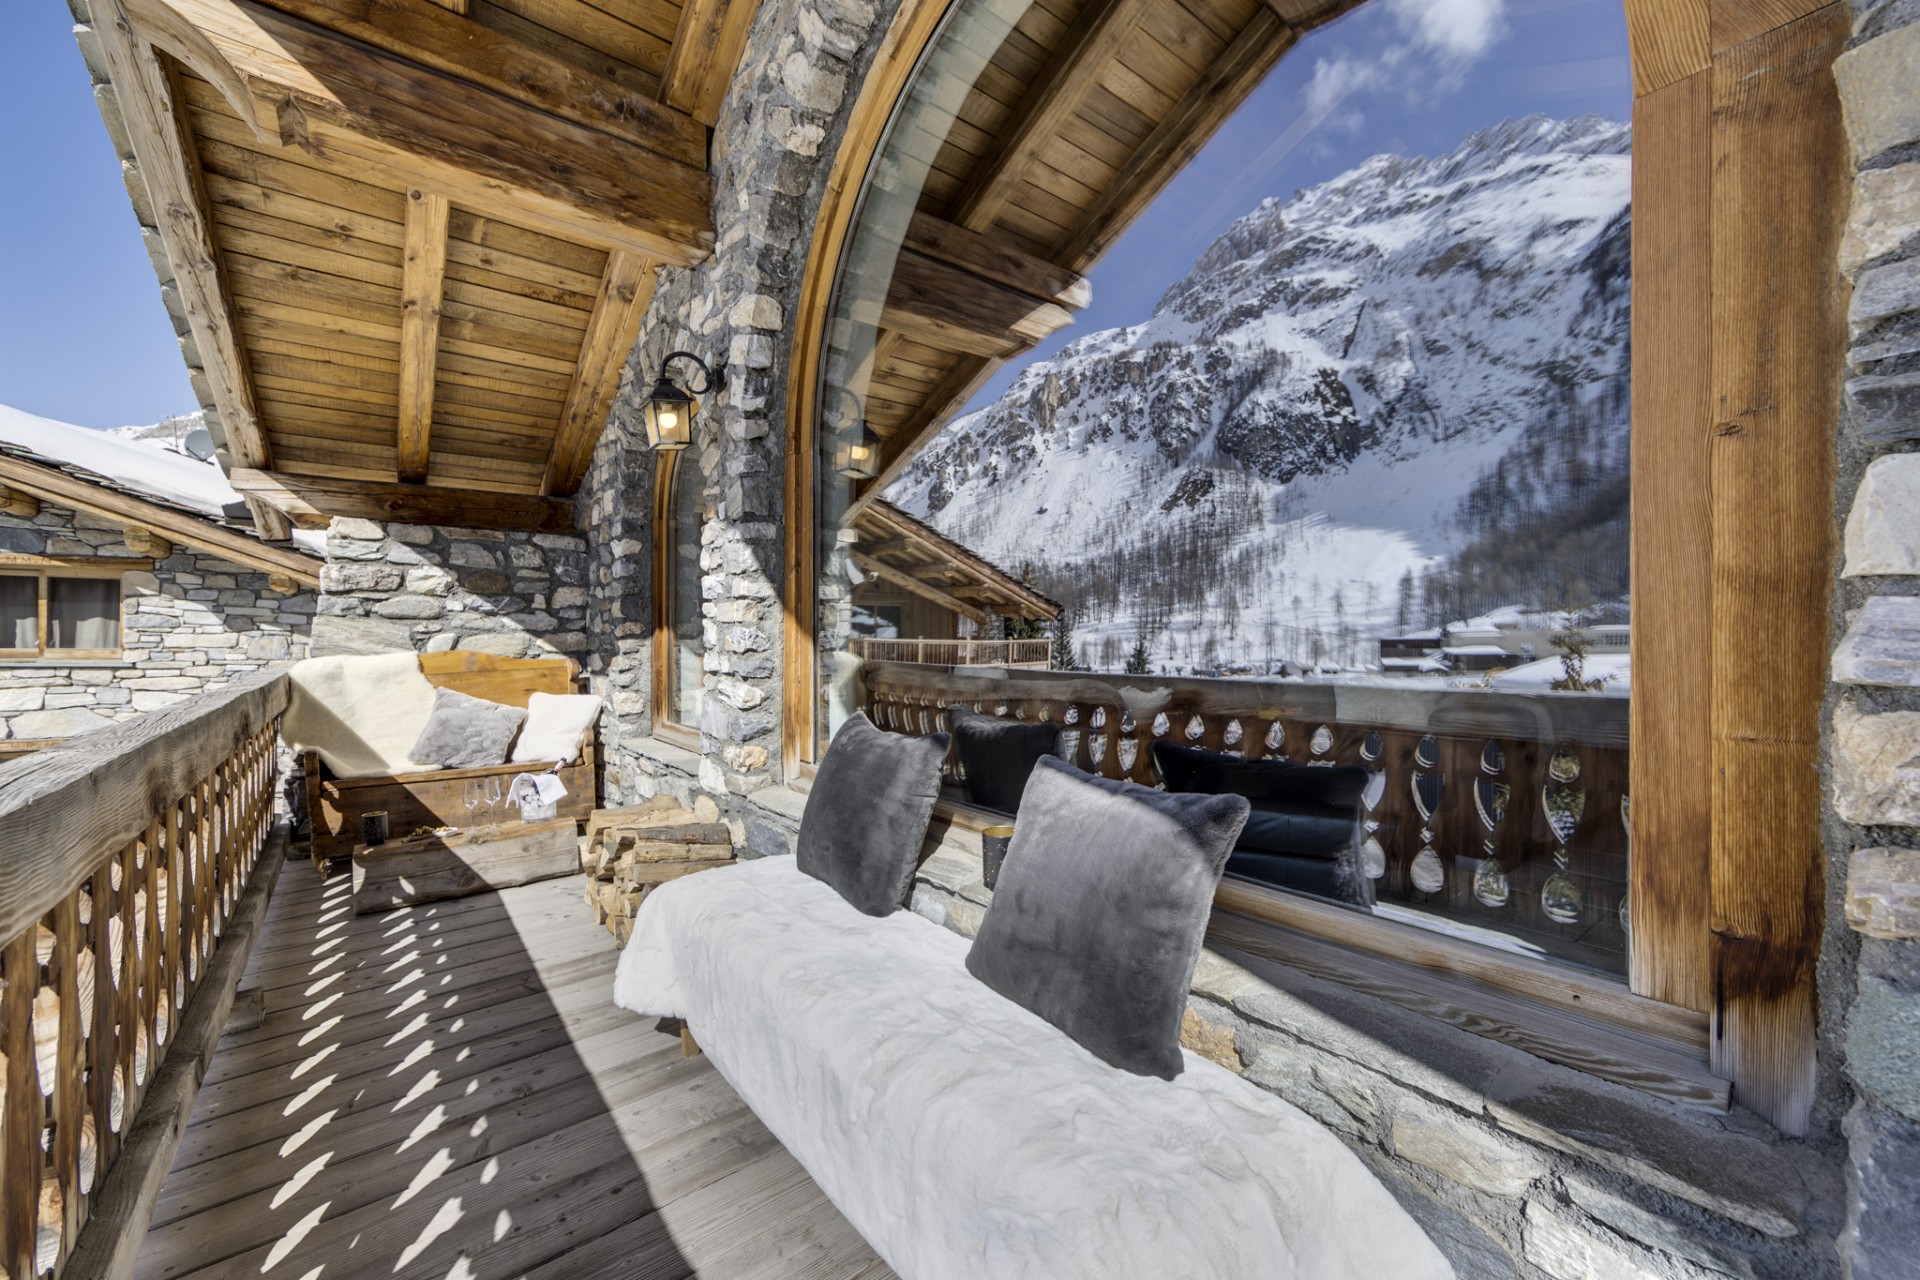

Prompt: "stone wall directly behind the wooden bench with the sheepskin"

[313,520,588,658]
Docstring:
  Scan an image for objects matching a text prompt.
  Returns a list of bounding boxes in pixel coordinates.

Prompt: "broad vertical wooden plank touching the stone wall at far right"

[1711,4,1849,1134]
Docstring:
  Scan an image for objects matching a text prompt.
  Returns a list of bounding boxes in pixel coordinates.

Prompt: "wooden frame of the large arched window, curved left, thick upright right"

[781,0,1849,1134]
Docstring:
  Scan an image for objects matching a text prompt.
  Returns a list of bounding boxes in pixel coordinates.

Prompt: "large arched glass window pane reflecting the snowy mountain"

[814,0,1632,973]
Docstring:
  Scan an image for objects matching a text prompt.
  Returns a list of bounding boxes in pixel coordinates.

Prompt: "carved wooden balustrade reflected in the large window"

[862,662,1628,973]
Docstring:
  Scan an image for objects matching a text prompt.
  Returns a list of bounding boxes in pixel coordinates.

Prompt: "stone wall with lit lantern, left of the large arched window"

[580,0,893,825]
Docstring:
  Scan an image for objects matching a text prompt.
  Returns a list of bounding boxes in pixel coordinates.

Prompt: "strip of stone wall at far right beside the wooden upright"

[1822,0,1920,1280]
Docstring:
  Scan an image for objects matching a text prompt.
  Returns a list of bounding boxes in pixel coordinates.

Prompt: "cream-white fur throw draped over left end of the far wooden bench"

[280,652,440,777]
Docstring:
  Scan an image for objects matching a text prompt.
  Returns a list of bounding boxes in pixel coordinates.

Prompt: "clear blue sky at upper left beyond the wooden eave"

[0,0,198,426]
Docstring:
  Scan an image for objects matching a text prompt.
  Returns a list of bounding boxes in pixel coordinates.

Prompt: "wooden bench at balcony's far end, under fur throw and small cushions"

[300,651,599,875]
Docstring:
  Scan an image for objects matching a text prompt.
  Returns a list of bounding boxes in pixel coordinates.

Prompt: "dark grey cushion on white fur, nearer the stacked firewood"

[795,712,947,915]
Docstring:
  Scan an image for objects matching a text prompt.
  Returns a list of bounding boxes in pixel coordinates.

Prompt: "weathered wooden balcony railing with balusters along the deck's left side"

[0,674,286,1280]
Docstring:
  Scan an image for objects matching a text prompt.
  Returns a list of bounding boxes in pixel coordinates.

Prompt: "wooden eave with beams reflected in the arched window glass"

[847,0,1357,512]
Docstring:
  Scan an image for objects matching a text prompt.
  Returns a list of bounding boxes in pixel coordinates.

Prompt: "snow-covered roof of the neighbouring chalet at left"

[0,405,321,587]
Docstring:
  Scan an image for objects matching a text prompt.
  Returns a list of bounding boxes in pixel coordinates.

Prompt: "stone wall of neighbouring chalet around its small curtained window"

[0,503,315,741]
